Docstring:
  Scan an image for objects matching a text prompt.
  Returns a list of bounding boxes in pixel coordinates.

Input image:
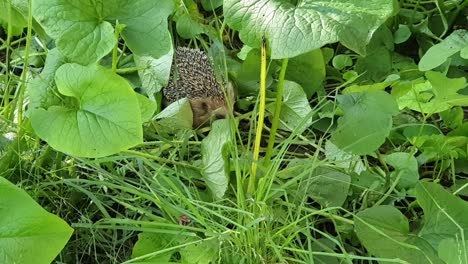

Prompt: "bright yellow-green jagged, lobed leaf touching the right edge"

[397,71,468,114]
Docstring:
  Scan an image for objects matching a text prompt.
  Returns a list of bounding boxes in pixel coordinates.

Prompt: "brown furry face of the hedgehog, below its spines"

[190,97,230,128]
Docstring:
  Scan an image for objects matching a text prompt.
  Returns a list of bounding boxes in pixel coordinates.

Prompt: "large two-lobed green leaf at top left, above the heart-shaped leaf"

[33,0,173,64]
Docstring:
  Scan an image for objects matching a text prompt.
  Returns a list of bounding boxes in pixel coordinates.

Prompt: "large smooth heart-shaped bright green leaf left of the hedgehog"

[31,64,143,157]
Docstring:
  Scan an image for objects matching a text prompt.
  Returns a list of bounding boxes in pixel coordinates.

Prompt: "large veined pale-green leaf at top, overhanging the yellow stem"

[224,0,394,59]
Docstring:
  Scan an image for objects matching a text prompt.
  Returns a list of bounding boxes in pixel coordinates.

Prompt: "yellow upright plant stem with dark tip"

[247,39,266,195]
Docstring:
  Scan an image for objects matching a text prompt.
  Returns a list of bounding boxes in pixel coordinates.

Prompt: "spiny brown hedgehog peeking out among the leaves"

[163,47,233,128]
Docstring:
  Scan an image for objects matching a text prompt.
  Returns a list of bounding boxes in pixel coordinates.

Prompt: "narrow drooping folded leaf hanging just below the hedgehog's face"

[201,119,231,199]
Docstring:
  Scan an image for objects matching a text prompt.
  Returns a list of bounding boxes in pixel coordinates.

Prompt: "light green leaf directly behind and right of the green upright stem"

[269,80,312,131]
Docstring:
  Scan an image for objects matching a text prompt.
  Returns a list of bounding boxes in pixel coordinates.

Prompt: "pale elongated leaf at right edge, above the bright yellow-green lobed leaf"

[419,29,468,71]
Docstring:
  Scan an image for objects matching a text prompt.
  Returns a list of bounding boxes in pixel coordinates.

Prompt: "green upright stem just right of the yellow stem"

[264,58,288,168]
